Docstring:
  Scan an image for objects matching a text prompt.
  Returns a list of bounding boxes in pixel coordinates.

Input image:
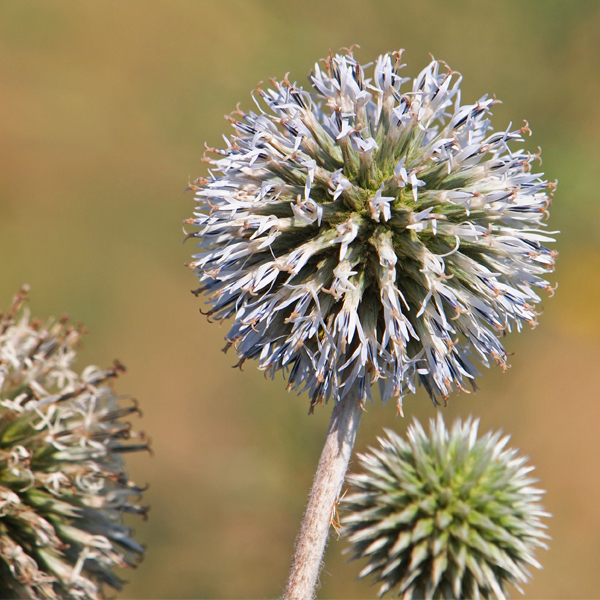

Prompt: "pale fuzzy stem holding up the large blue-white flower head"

[283,386,362,600]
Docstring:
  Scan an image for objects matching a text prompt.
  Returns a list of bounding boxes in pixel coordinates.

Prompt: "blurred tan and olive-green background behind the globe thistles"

[0,0,600,598]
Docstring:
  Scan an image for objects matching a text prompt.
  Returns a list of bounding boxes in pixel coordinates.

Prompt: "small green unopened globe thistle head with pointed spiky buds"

[342,415,549,598]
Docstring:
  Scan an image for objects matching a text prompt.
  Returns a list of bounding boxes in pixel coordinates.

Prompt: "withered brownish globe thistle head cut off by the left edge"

[0,292,148,600]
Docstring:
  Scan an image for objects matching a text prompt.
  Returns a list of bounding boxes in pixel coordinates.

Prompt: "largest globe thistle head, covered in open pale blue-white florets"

[186,52,556,410]
